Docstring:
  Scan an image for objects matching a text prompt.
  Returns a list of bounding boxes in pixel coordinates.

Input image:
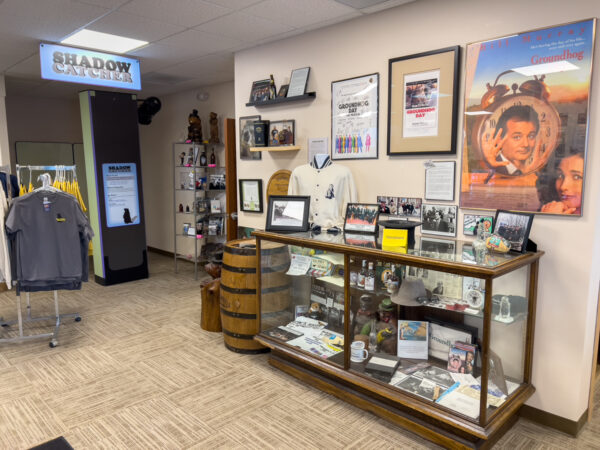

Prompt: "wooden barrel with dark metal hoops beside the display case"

[220,239,290,353]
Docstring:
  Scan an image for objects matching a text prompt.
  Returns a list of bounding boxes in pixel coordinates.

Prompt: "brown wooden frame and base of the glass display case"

[252,231,544,448]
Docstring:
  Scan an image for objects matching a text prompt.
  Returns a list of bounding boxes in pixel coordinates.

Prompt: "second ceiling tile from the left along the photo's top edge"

[120,0,232,27]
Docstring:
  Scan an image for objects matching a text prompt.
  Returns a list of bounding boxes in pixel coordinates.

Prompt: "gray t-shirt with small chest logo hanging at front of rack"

[6,190,94,284]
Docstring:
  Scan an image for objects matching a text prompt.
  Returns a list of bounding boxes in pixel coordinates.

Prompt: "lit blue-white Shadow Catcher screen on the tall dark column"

[102,163,140,228]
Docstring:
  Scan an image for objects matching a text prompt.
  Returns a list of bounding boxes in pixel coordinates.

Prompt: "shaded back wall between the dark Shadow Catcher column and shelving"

[140,82,235,251]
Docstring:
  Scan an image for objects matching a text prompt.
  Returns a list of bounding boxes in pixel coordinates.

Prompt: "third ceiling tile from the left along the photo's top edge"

[244,0,356,28]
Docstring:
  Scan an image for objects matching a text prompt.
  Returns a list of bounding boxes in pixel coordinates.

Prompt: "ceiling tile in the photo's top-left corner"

[0,0,109,41]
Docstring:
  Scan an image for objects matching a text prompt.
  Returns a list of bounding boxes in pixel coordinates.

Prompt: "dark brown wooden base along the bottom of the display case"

[268,348,534,449]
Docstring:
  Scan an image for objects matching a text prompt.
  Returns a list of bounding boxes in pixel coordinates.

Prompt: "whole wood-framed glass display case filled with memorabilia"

[253,231,543,448]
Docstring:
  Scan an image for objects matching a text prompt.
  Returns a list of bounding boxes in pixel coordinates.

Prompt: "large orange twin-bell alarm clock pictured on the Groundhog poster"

[471,70,561,176]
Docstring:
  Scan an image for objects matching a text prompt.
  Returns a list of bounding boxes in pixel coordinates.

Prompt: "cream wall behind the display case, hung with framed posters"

[235,0,600,420]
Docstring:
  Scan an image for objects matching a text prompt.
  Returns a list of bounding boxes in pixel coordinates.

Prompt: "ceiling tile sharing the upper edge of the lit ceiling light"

[87,11,185,42]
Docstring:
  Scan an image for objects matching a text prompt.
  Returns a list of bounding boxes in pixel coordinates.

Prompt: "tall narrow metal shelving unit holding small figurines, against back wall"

[173,143,226,279]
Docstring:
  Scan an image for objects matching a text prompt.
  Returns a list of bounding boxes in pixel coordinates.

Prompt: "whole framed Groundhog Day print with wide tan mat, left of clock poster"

[387,46,460,155]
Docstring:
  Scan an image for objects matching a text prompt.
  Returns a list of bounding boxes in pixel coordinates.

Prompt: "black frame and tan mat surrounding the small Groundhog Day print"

[387,45,460,156]
